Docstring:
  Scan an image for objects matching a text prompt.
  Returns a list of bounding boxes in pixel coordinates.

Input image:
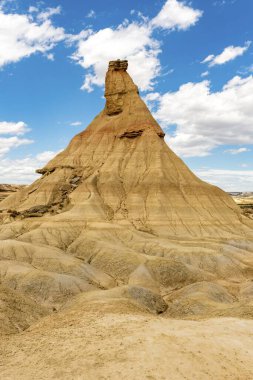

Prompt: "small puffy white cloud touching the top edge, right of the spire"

[152,0,203,30]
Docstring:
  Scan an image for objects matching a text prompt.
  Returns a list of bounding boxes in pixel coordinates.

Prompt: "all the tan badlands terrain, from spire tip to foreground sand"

[0,61,253,380]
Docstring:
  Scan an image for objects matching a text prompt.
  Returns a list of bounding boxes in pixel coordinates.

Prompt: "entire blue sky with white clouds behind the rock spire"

[0,0,253,191]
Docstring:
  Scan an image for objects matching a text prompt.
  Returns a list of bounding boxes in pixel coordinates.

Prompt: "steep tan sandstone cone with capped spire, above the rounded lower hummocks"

[0,60,252,238]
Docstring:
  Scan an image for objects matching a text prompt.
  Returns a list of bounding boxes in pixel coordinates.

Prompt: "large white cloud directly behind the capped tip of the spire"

[72,23,160,91]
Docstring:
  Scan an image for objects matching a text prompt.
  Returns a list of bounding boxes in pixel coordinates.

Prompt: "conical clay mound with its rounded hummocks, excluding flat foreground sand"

[0,61,253,316]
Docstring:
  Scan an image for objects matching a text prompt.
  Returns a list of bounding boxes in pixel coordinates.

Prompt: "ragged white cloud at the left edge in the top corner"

[0,7,66,67]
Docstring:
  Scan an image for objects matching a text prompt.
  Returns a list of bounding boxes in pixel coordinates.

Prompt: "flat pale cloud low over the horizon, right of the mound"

[194,169,253,191]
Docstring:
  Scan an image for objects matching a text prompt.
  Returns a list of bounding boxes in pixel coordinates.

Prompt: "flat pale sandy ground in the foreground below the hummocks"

[0,303,253,380]
